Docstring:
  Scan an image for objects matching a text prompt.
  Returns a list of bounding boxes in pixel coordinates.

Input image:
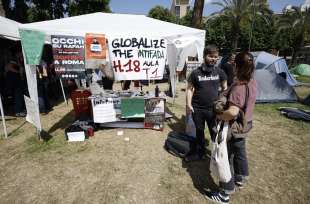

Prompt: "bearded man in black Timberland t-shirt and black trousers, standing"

[185,45,227,160]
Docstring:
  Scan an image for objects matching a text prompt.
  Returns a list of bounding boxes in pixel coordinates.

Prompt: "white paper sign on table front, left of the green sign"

[92,97,117,123]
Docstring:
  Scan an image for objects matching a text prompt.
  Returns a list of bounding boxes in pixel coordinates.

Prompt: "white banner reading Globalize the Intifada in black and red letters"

[109,37,167,80]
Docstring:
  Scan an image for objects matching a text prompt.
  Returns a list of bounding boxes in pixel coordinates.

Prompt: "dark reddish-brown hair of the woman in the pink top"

[235,52,255,81]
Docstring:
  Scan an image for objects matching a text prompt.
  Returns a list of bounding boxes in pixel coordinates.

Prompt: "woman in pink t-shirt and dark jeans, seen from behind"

[205,52,257,203]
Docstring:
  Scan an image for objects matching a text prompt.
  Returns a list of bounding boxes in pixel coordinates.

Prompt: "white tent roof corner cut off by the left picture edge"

[0,16,21,40]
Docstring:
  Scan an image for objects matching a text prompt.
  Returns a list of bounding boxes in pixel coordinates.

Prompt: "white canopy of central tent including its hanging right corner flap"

[20,13,205,70]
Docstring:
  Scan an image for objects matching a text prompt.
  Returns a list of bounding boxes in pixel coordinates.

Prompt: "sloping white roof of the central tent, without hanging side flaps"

[22,12,205,39]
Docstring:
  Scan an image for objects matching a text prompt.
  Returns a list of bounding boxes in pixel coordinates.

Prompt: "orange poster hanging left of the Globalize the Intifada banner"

[85,33,107,69]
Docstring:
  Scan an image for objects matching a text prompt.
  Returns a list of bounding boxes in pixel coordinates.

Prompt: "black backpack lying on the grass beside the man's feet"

[164,132,196,158]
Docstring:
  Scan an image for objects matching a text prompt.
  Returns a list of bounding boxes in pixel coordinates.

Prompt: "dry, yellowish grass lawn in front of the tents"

[0,83,310,204]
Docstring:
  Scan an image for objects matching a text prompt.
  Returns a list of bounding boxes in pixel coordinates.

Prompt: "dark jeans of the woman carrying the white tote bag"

[220,137,249,194]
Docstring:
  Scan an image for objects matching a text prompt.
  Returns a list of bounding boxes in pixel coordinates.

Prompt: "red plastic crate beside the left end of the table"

[70,89,91,119]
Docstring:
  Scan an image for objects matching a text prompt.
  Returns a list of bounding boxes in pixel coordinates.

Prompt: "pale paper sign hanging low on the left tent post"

[24,96,42,131]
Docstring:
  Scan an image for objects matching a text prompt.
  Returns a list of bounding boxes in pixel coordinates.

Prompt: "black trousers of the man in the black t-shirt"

[193,108,216,156]
